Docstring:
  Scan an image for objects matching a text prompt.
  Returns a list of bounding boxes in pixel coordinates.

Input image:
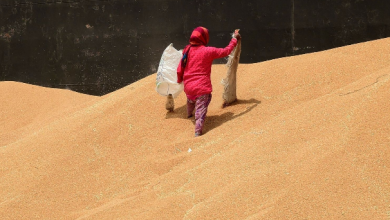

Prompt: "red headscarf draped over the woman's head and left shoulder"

[181,27,209,71]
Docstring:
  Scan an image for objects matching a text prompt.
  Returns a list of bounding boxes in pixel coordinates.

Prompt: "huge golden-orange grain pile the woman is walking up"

[0,38,390,219]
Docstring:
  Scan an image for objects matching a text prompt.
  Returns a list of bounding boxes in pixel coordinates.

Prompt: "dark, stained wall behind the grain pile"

[0,0,390,95]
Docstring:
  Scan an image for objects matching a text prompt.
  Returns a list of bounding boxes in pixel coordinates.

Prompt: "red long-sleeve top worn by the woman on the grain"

[177,38,237,99]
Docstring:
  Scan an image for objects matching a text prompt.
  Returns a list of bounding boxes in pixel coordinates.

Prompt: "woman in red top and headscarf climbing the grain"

[177,27,240,136]
